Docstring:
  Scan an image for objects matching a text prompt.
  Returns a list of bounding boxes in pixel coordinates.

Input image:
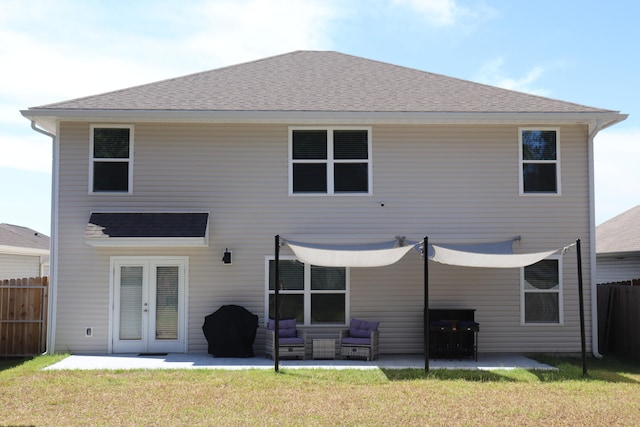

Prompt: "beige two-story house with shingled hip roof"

[22,51,626,354]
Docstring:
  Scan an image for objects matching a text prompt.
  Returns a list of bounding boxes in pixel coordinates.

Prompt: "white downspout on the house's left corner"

[31,120,60,354]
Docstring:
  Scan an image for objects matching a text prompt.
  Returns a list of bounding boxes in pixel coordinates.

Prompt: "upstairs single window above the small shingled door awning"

[89,124,133,194]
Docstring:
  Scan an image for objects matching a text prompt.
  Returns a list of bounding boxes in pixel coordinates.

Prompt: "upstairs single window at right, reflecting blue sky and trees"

[518,128,560,195]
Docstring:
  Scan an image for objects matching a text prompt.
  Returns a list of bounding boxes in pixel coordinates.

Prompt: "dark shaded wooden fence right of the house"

[598,279,640,358]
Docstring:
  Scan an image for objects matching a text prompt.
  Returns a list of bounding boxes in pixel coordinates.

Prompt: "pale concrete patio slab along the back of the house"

[45,353,557,371]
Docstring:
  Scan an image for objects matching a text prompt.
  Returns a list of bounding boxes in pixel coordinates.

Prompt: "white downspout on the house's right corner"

[588,119,604,359]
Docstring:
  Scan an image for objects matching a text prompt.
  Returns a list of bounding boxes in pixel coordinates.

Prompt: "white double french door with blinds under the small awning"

[111,257,187,353]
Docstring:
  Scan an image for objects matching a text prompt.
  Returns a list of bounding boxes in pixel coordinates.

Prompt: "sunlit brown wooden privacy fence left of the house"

[0,277,49,357]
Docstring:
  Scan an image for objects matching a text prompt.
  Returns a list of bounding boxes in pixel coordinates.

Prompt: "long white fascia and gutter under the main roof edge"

[21,109,627,131]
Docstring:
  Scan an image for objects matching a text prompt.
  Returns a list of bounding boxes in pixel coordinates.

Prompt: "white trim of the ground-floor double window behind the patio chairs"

[264,255,351,328]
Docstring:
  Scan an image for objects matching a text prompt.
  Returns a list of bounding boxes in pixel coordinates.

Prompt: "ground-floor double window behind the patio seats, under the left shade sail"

[265,256,349,326]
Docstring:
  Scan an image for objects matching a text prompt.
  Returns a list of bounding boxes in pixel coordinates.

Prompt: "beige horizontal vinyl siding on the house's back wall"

[56,123,590,354]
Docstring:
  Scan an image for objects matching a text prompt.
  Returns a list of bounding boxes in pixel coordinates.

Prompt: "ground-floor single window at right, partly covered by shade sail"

[520,255,563,325]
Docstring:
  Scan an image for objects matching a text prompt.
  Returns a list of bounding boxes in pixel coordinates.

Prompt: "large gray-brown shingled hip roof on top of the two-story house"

[35,51,612,113]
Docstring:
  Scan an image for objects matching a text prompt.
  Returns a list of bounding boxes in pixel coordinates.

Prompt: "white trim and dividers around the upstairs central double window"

[287,126,373,197]
